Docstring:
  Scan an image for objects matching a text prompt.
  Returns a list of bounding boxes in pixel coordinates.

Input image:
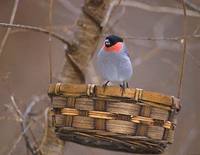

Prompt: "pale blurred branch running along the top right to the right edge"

[121,0,200,17]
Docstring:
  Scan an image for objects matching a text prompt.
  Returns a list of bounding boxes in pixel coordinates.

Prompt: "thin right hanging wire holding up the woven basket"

[177,0,187,98]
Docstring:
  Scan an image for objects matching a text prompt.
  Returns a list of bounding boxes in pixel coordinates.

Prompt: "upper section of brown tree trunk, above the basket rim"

[60,0,111,83]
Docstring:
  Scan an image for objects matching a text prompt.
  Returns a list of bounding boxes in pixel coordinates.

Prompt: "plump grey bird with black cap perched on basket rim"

[96,35,133,89]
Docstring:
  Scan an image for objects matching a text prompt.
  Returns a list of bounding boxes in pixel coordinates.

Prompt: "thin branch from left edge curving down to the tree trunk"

[0,23,72,47]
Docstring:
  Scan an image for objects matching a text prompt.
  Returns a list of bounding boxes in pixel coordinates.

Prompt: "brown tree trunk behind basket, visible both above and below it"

[43,0,110,155]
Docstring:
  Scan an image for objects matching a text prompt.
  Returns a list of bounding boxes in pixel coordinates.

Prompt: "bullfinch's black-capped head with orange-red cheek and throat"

[104,35,123,52]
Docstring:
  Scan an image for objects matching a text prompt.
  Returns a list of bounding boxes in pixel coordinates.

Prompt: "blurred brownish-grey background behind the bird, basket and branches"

[0,0,200,155]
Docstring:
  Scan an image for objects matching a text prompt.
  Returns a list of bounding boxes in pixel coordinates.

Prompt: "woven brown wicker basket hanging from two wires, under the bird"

[48,83,180,154]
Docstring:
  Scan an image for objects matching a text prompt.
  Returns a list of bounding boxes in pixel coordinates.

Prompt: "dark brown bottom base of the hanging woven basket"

[56,127,167,154]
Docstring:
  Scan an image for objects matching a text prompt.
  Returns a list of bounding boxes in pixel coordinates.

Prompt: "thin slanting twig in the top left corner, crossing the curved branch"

[0,0,19,56]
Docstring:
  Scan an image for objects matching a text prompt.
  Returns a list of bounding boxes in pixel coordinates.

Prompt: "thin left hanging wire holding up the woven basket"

[48,0,53,83]
